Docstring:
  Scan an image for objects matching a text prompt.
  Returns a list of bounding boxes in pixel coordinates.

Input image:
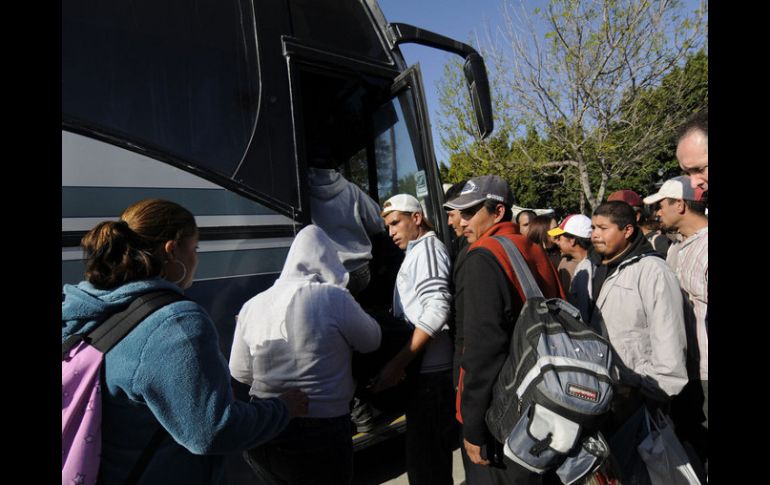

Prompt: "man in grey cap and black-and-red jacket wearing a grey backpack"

[445,175,564,484]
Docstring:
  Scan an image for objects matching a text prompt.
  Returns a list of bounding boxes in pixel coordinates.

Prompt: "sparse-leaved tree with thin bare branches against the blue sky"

[492,0,705,208]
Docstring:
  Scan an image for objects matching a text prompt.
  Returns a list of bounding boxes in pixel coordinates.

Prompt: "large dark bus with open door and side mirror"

[61,0,493,476]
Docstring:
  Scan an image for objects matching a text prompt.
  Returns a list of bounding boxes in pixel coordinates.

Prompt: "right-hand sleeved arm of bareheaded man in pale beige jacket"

[638,256,687,400]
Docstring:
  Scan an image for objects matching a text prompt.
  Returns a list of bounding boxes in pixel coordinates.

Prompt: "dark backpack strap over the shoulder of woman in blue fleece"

[85,290,187,353]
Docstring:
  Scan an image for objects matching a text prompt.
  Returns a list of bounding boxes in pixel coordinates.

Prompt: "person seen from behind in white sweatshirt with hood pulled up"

[230,225,381,484]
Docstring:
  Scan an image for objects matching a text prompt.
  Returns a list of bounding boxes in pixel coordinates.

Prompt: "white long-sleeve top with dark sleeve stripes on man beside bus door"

[393,231,452,373]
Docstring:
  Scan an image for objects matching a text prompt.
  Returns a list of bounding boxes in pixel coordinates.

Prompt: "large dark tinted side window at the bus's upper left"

[62,0,259,176]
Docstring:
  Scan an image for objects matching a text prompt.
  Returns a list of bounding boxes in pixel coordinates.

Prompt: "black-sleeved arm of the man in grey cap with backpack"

[460,249,520,454]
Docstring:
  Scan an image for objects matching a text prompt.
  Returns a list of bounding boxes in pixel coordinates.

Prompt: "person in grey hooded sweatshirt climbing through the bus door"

[308,163,385,296]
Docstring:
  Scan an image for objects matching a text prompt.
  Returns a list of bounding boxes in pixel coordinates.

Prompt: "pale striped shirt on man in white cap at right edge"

[666,226,709,381]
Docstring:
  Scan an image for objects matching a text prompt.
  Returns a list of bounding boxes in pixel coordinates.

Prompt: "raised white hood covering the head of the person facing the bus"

[278,224,348,288]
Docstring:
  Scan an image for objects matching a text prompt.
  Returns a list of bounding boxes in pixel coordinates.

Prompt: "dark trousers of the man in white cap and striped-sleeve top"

[406,369,458,485]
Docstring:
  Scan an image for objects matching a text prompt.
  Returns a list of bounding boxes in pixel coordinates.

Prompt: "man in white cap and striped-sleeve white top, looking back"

[372,194,456,485]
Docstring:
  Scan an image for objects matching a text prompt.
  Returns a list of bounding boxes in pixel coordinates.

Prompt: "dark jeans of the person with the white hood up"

[244,414,353,485]
